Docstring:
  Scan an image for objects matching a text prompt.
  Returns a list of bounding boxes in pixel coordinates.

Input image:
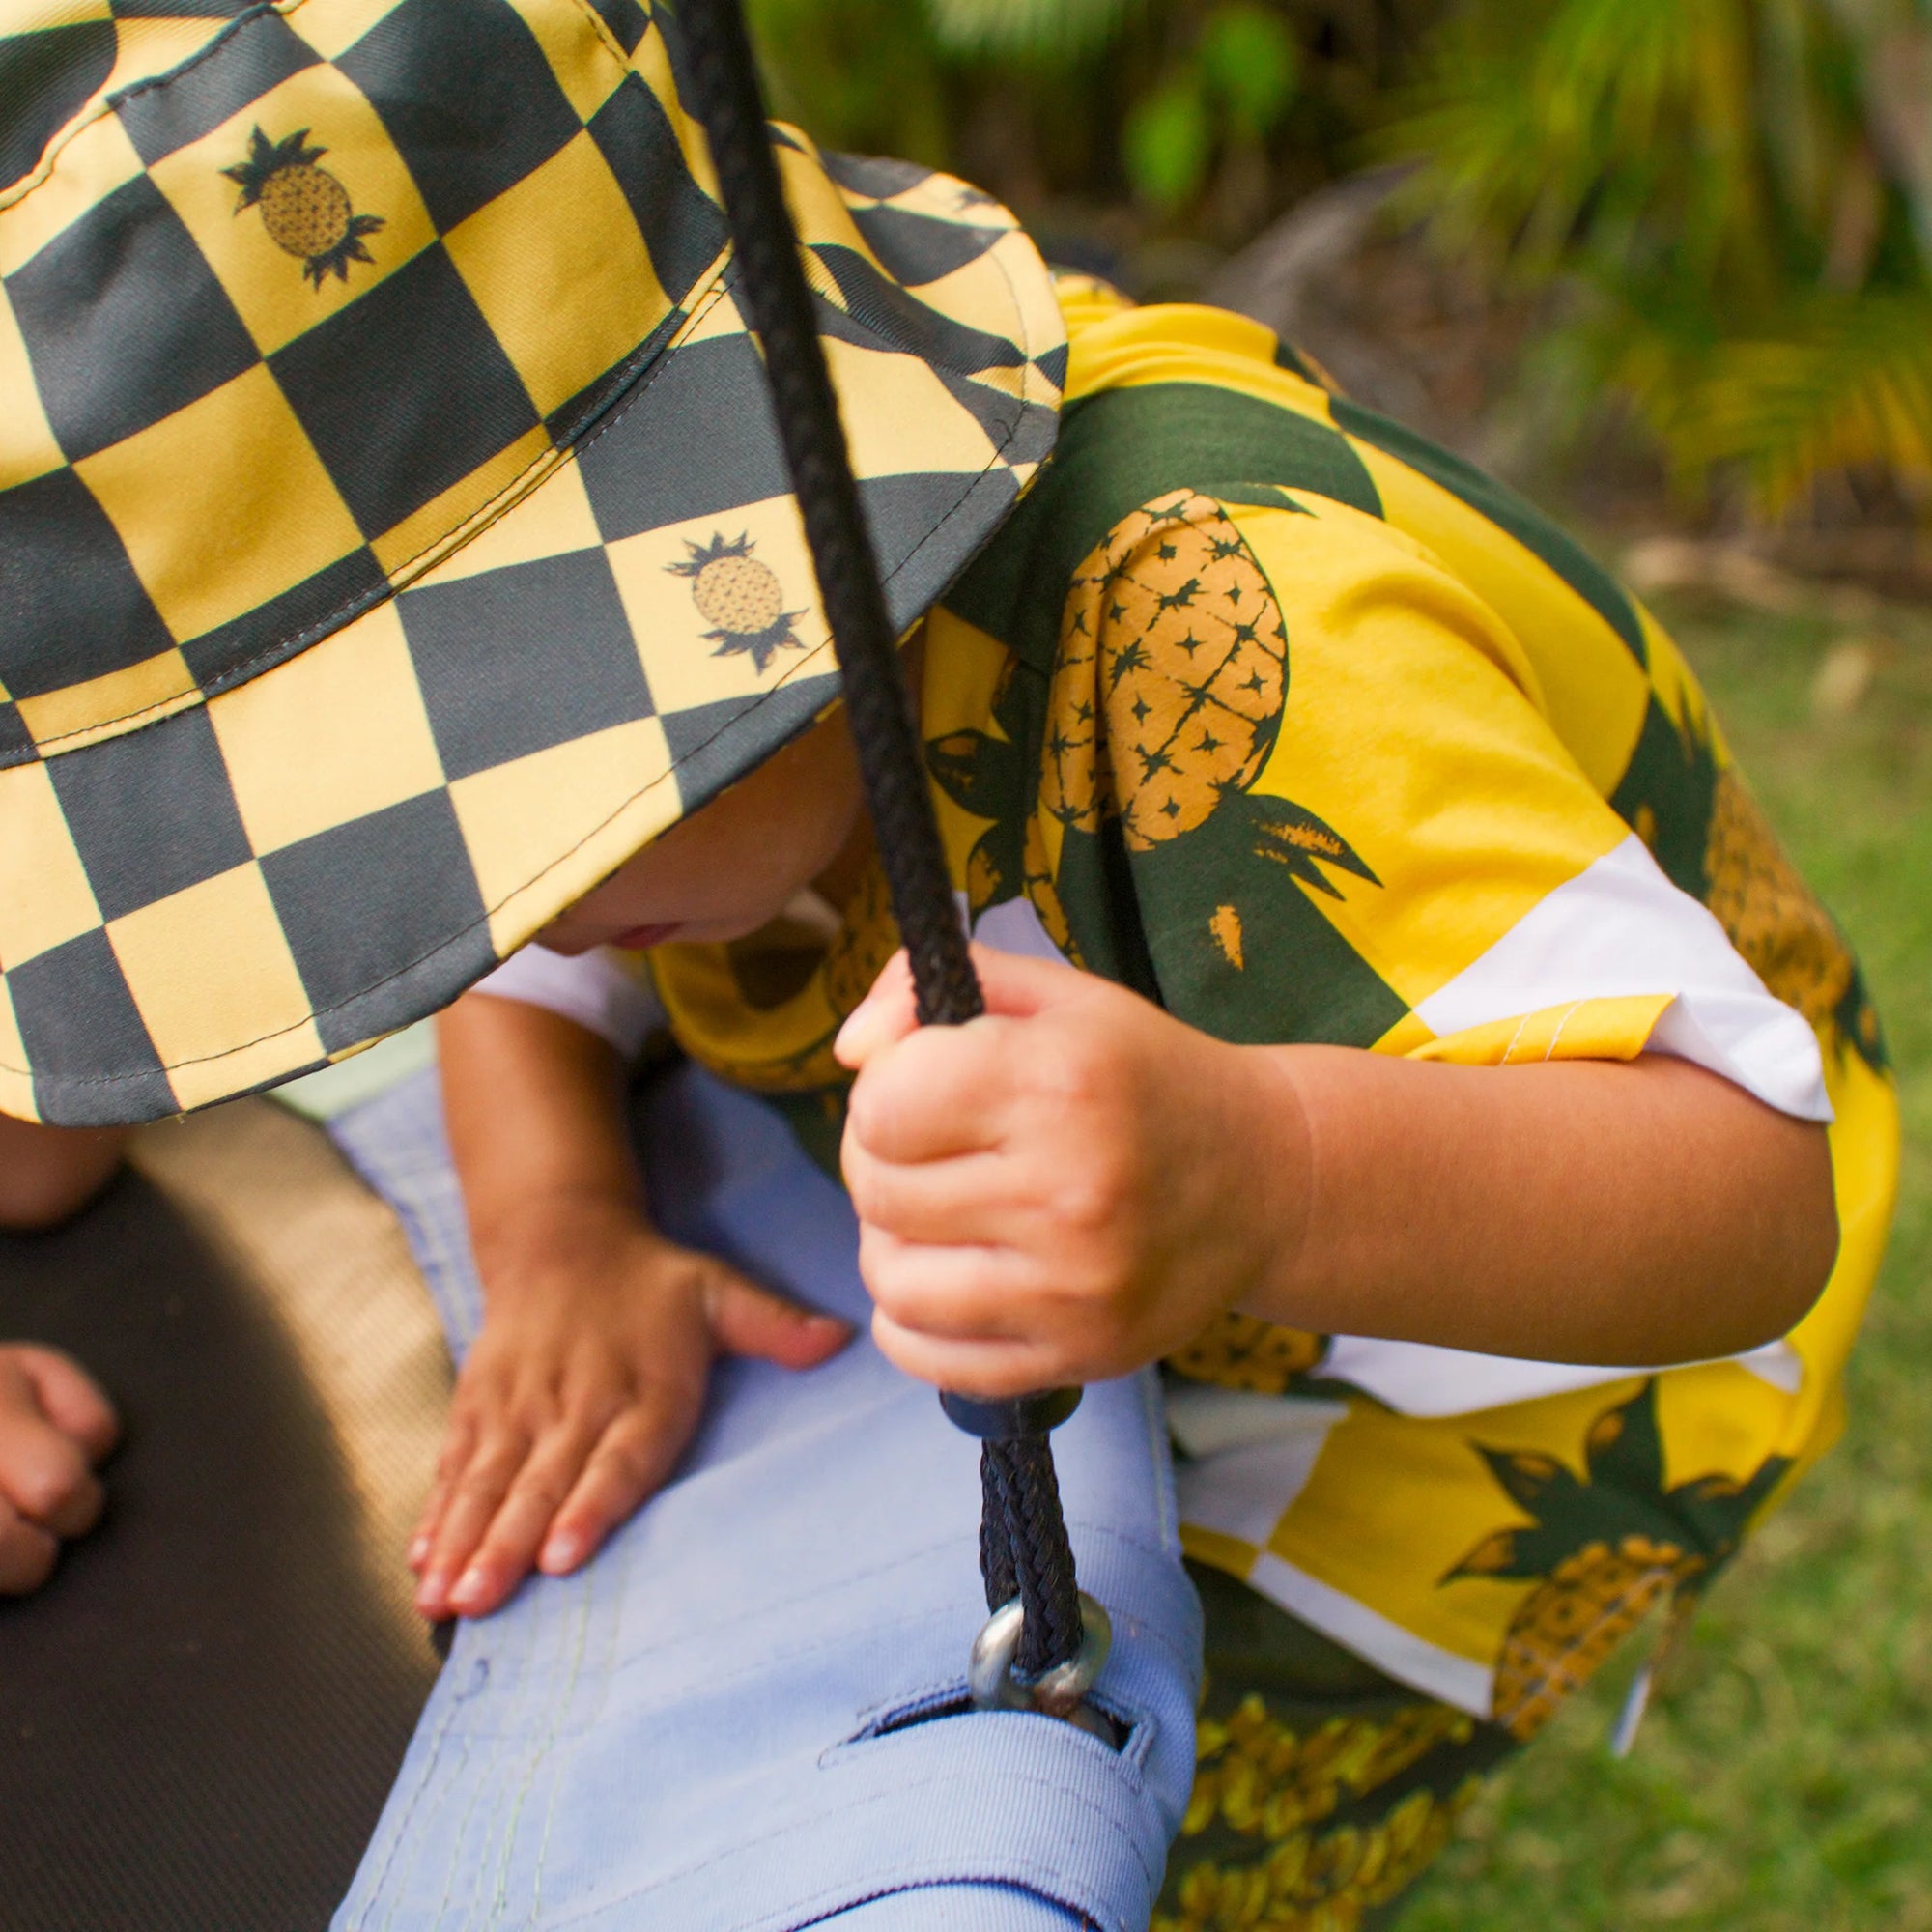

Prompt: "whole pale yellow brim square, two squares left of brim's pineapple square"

[209,603,442,852]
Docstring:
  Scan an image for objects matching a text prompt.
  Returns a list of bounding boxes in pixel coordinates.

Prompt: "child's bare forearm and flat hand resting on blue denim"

[410,993,848,1617]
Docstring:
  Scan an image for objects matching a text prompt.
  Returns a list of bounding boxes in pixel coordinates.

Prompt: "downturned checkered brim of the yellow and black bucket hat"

[0,135,1065,1124]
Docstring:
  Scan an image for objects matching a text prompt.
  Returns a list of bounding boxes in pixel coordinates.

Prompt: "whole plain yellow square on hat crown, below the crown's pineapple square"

[75,363,361,641]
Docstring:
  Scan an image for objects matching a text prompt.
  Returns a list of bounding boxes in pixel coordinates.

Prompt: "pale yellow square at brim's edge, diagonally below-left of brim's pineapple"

[450,719,680,956]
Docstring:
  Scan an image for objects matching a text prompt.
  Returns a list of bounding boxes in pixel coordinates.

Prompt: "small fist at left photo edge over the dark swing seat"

[0,1343,120,1596]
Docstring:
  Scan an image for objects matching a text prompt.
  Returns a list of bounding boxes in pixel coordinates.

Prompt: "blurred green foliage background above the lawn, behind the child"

[753,0,1932,553]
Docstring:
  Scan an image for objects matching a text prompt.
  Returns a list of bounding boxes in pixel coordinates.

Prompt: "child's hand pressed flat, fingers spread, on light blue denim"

[410,1196,850,1617]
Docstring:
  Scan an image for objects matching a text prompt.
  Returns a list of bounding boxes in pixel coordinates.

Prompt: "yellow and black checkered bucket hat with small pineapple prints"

[0,0,1066,1122]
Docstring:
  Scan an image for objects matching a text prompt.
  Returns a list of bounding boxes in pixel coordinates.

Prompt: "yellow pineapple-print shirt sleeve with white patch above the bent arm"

[1009,491,1830,1119]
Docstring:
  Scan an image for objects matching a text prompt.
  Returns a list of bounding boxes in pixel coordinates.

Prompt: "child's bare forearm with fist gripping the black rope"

[840,952,1837,1393]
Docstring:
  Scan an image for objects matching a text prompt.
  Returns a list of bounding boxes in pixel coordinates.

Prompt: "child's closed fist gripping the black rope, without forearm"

[838,947,1308,1395]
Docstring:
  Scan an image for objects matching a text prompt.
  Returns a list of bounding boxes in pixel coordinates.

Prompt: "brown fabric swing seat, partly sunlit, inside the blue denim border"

[0,1099,448,1932]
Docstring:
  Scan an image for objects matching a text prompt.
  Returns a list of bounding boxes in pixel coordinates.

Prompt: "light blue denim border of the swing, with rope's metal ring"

[332,1065,1200,1932]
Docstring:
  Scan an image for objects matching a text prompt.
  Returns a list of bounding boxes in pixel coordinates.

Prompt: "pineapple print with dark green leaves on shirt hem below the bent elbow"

[1443,1378,1789,1739]
